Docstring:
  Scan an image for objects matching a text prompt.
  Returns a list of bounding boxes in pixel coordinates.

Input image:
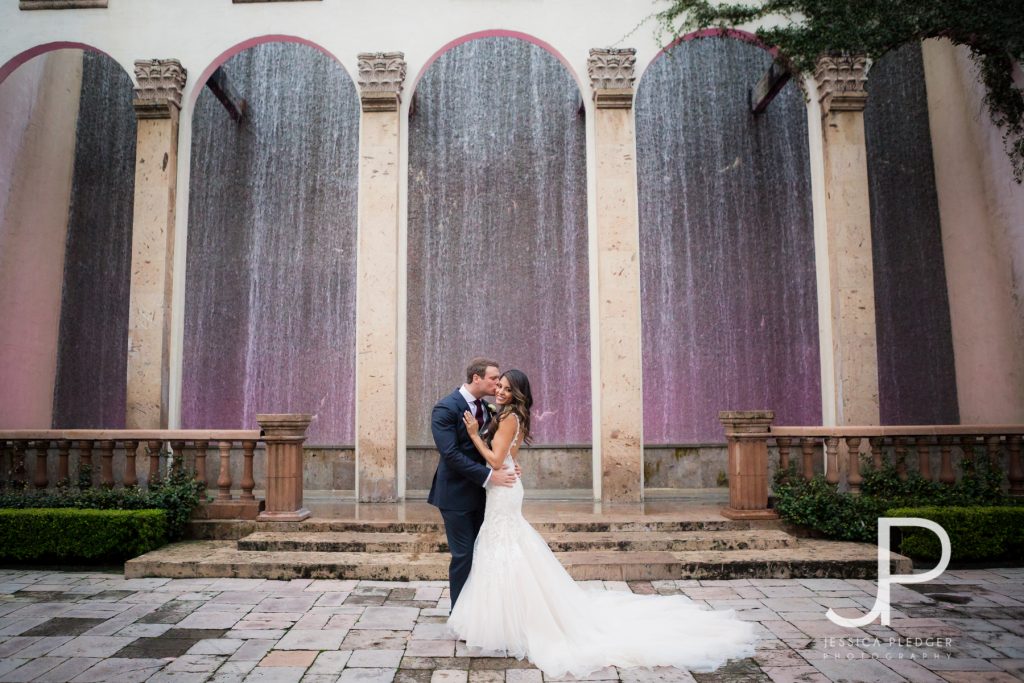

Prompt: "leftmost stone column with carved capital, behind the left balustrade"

[125,59,186,429]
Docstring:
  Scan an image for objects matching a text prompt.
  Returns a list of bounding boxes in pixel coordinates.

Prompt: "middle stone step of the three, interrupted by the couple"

[238,529,796,553]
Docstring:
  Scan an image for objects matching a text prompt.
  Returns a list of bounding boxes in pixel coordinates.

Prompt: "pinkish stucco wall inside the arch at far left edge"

[0,50,82,429]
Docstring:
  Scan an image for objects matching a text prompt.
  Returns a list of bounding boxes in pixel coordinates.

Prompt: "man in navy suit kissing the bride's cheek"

[427,358,516,607]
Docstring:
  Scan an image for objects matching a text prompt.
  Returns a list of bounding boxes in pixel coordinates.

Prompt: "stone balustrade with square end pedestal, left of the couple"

[0,415,309,519]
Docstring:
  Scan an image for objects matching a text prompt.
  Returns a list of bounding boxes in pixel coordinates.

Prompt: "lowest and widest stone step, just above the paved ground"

[125,539,912,581]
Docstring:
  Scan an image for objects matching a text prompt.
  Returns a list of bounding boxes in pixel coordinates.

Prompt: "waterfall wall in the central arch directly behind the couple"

[407,37,591,445]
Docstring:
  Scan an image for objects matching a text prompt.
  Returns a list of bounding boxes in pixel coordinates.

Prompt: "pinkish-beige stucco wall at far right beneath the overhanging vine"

[923,41,1024,424]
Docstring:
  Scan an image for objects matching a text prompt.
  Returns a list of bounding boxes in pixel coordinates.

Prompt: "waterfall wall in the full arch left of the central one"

[181,43,359,445]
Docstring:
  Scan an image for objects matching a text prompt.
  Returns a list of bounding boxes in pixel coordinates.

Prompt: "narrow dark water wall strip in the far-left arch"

[53,51,135,429]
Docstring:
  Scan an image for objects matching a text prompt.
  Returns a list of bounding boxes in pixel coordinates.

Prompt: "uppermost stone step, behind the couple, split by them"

[188,514,761,541]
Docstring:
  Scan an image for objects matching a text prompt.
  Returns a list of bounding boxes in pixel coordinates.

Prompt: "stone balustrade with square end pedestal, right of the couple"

[719,411,1024,519]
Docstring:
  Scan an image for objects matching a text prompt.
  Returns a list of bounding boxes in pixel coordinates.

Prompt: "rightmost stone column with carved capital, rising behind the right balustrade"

[814,56,879,425]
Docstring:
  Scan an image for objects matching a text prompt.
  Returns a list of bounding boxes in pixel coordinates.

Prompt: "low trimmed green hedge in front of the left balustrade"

[0,508,167,561]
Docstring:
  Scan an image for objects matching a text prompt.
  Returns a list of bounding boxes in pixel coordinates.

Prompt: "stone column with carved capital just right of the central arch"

[587,48,643,503]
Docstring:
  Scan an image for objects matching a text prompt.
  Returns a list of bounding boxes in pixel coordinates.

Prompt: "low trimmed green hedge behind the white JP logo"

[886,506,1024,560]
